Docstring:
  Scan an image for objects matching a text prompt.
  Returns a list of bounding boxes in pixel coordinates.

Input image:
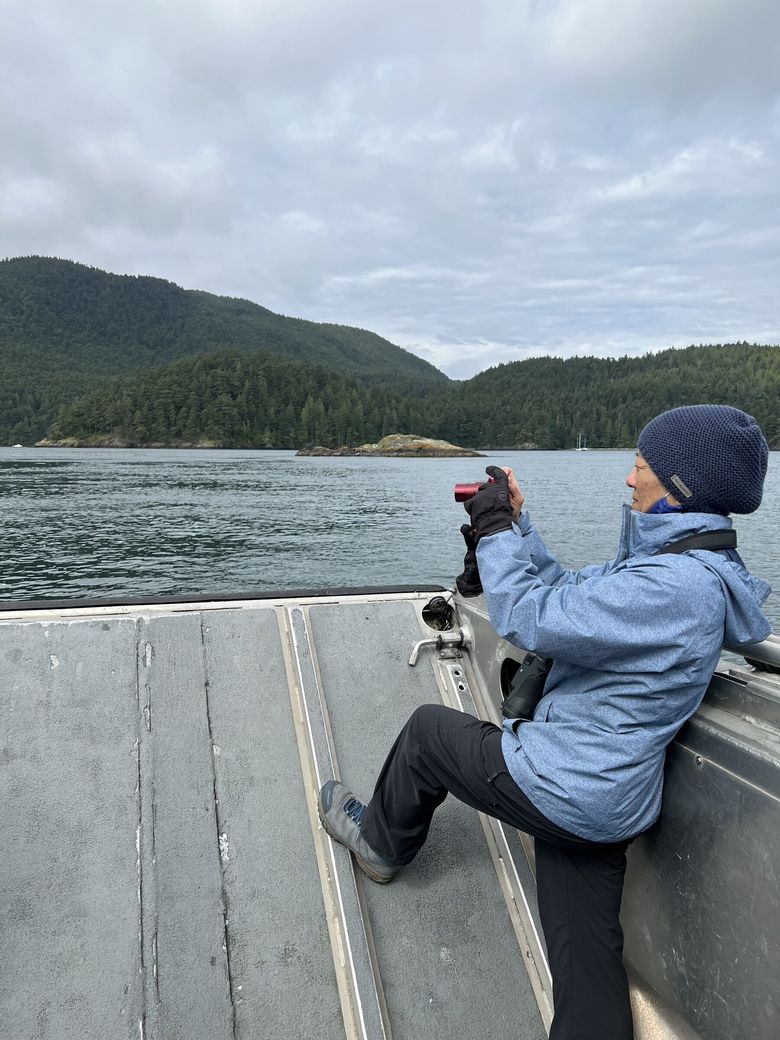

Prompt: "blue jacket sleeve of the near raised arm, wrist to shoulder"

[477,531,724,672]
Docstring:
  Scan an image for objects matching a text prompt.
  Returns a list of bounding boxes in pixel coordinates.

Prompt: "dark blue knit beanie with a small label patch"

[638,405,769,515]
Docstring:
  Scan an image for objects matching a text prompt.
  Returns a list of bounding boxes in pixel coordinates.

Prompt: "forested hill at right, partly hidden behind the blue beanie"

[436,343,780,448]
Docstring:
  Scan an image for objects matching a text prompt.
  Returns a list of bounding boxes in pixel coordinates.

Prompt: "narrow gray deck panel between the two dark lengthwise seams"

[138,614,233,1040]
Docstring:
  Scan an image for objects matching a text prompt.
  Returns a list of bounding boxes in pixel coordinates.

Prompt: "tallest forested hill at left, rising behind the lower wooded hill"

[0,257,447,443]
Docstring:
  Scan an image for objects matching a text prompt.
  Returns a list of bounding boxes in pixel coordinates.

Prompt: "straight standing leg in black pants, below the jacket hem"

[536,838,633,1040]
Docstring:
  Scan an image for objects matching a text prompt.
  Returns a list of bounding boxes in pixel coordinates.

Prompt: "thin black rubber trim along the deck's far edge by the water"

[0,584,451,614]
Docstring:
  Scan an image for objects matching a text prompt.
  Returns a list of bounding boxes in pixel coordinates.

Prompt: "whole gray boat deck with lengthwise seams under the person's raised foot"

[0,593,549,1040]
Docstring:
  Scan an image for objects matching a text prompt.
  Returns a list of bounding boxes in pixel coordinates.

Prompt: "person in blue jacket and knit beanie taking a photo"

[319,405,771,1040]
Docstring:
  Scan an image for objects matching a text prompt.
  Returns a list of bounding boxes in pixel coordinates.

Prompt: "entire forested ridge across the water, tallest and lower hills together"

[0,258,780,448]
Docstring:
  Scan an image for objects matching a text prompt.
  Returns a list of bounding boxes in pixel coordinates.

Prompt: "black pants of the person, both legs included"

[362,704,633,1040]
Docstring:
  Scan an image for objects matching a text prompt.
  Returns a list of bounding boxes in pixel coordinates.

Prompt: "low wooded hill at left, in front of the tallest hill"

[51,350,428,448]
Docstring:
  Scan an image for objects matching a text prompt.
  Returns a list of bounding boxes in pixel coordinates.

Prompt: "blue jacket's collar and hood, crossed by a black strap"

[617,504,772,648]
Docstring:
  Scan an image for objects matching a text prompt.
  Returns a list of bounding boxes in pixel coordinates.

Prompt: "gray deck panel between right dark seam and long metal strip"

[203,608,344,1040]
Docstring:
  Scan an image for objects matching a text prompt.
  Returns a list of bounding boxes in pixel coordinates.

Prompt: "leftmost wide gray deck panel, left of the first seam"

[0,619,142,1040]
